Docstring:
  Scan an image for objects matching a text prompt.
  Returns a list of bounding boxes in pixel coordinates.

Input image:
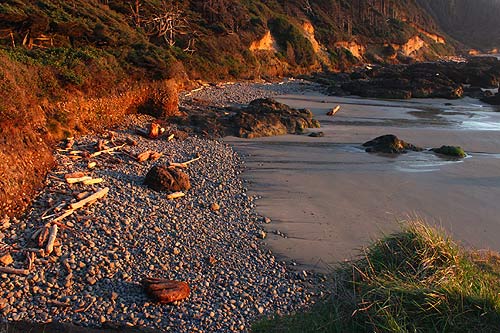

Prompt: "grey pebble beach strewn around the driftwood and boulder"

[0,83,321,332]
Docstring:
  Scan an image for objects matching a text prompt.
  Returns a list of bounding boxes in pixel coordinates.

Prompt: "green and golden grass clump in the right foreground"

[253,222,500,332]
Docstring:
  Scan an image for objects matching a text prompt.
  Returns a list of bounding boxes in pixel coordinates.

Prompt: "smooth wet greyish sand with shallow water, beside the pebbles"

[226,93,500,271]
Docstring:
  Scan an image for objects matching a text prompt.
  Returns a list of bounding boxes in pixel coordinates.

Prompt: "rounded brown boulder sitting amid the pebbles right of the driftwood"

[144,165,191,192]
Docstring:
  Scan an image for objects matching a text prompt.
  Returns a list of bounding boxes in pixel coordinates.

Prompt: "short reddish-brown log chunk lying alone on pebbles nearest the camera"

[141,277,191,304]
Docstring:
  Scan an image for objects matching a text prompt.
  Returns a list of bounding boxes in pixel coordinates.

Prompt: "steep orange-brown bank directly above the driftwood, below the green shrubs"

[0,55,178,216]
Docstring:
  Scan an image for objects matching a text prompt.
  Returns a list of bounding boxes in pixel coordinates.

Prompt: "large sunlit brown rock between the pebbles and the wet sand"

[232,98,319,138]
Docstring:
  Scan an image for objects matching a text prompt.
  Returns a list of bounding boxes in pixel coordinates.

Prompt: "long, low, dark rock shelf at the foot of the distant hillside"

[317,57,500,99]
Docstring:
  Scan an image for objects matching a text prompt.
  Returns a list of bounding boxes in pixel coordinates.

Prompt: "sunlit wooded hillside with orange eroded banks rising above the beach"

[0,0,454,215]
